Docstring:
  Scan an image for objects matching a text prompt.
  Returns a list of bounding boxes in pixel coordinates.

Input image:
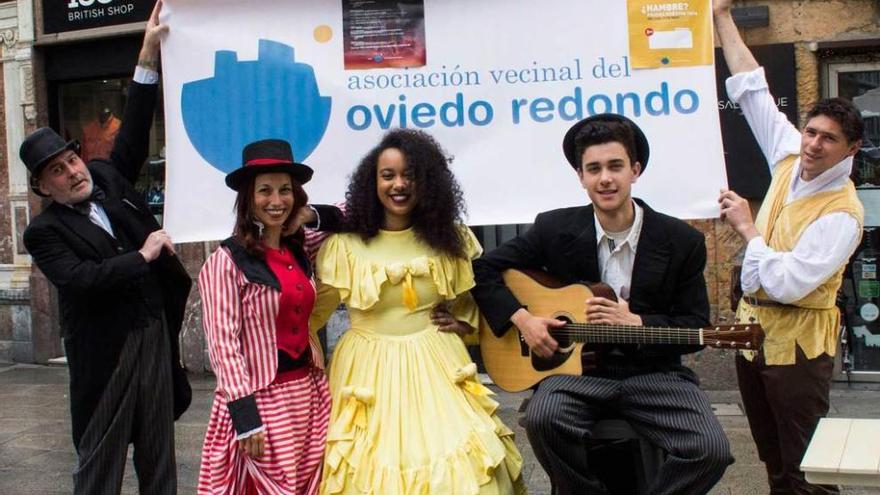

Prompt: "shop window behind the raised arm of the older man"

[58,78,165,223]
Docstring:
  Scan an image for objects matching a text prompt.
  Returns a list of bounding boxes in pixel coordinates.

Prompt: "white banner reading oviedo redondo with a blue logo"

[162,0,727,242]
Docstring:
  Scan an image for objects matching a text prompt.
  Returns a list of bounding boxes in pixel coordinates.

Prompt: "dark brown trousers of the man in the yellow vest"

[736,347,840,495]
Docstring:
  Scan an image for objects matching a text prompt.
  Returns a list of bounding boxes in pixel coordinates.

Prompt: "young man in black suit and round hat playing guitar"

[472,114,732,494]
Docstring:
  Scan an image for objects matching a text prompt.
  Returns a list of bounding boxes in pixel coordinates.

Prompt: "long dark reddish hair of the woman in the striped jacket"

[232,174,309,259]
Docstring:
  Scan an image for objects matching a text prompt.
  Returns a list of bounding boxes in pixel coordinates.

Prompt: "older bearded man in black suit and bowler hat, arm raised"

[20,1,191,494]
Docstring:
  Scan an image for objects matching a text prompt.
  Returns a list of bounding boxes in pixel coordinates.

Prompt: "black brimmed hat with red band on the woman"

[226,139,314,191]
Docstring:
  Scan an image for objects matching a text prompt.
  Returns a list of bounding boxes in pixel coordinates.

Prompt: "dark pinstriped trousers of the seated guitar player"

[526,368,733,495]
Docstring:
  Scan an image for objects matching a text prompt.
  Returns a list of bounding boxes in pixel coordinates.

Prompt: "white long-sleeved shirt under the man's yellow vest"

[726,67,861,303]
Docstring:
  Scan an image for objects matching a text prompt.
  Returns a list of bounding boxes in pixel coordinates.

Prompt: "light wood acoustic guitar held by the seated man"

[479,270,764,392]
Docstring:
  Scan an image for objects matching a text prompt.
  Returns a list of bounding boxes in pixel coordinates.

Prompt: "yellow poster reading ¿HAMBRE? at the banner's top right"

[627,0,714,69]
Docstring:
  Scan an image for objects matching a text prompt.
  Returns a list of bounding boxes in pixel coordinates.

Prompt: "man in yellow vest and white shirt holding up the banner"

[714,0,864,494]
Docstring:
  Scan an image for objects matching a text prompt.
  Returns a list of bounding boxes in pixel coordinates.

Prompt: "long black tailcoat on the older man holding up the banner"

[24,82,192,444]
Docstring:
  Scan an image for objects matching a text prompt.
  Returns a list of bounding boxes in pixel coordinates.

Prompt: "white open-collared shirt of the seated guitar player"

[593,201,644,300]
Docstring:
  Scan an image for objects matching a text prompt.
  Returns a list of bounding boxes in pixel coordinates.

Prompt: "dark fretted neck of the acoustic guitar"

[553,323,704,345]
